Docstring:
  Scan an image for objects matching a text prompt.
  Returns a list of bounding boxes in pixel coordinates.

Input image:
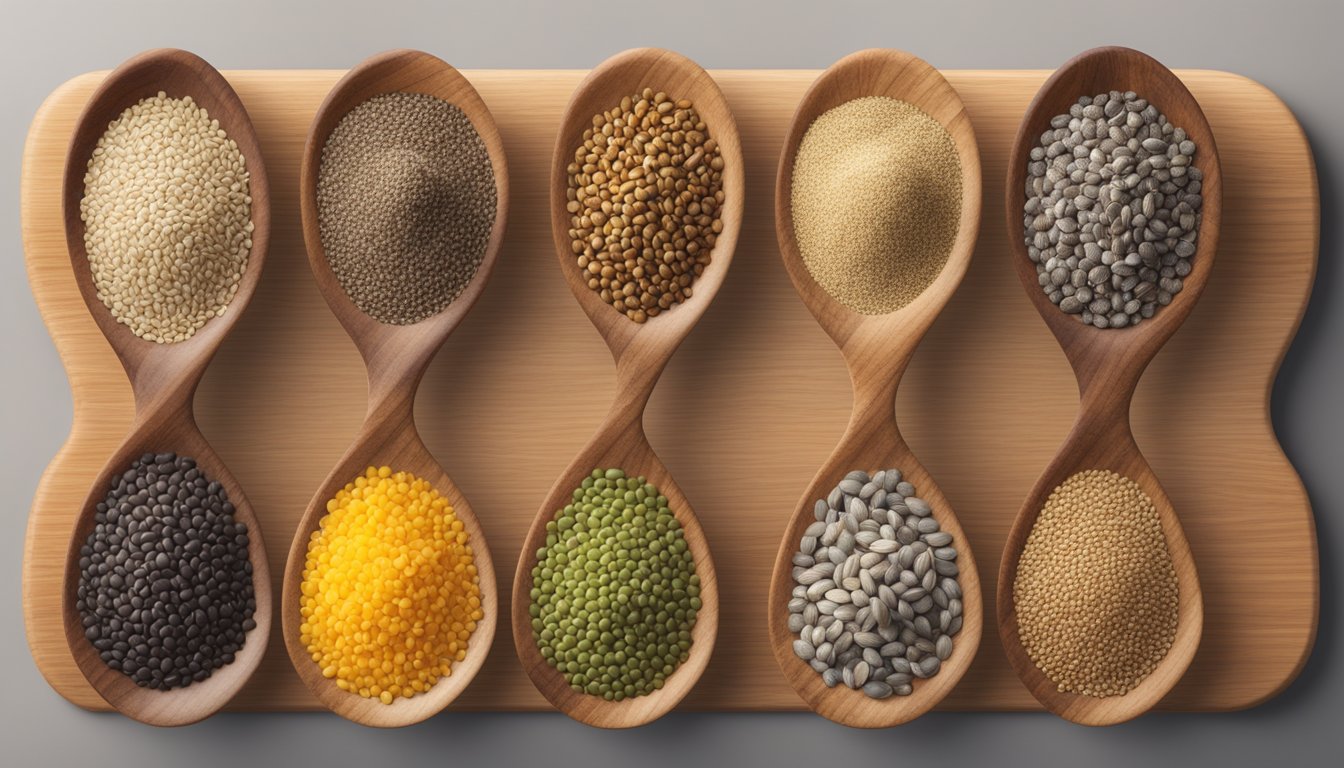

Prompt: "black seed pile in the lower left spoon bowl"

[77,453,257,690]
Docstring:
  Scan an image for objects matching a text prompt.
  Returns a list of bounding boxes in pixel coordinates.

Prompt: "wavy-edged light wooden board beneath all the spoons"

[23,71,1320,710]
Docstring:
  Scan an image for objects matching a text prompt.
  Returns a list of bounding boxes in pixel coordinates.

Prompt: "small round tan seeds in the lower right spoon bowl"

[1013,469,1177,697]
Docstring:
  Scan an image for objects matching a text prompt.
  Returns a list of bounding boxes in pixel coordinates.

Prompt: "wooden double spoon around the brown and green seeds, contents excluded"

[512,48,746,728]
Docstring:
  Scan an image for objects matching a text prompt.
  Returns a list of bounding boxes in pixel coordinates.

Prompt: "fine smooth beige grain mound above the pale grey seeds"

[790,97,961,315]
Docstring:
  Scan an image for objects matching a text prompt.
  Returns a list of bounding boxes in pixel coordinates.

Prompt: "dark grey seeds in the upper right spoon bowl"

[1023,90,1204,328]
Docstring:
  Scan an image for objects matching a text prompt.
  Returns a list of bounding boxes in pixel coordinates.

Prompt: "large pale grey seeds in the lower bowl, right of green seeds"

[789,469,962,698]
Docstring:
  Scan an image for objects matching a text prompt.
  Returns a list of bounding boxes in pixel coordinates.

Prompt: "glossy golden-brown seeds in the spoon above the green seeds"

[566,89,723,323]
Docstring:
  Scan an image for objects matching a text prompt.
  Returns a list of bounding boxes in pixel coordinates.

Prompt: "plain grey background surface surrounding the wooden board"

[0,0,1344,768]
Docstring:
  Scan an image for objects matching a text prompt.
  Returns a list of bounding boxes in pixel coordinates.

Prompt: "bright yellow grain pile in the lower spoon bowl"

[300,467,482,703]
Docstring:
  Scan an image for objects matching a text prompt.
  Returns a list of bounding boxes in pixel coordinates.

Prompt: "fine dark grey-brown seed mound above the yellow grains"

[317,93,497,325]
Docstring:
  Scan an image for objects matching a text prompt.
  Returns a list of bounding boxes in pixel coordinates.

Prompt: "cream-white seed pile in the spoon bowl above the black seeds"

[79,91,253,343]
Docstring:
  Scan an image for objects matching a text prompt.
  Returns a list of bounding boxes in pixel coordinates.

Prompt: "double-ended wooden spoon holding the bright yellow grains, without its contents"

[281,50,508,728]
